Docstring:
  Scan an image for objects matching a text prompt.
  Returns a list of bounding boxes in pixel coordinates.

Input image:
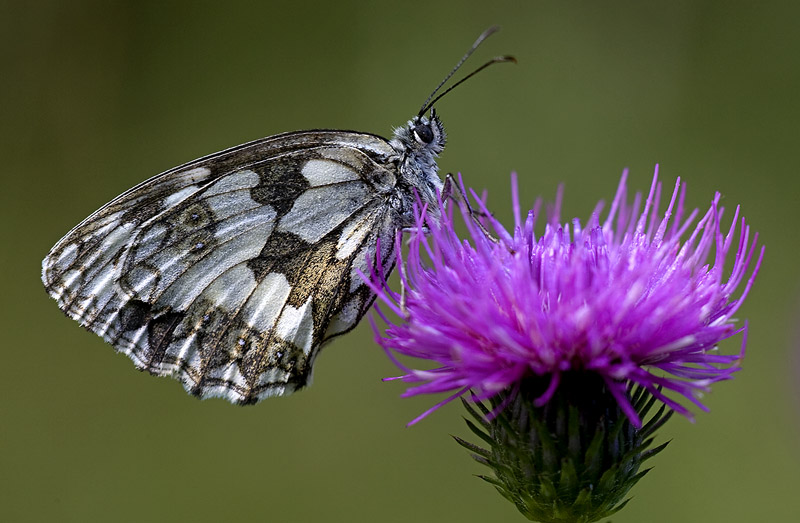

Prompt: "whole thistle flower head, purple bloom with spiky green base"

[370,167,764,522]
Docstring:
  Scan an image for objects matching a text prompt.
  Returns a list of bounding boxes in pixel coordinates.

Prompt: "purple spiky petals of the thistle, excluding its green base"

[371,166,764,427]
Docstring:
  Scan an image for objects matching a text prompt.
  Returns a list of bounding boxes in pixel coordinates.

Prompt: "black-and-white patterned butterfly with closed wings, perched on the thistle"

[42,27,513,404]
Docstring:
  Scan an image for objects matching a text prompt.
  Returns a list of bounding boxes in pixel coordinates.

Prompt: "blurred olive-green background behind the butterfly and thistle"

[0,0,800,523]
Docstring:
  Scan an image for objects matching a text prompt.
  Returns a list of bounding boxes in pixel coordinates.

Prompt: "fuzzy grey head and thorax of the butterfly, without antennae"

[389,111,447,227]
